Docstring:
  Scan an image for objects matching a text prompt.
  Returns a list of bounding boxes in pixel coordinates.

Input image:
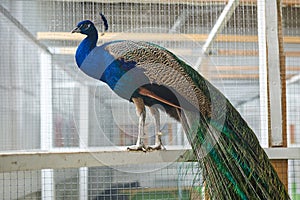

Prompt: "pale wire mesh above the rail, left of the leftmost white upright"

[0,2,40,150]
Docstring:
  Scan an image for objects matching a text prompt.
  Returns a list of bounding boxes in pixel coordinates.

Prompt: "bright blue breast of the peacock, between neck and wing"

[80,43,149,100]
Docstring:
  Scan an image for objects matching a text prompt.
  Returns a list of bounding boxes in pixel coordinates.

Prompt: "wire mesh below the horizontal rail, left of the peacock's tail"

[0,163,200,200]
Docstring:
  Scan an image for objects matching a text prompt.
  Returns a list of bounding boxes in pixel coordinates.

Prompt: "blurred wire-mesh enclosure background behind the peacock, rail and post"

[0,0,300,199]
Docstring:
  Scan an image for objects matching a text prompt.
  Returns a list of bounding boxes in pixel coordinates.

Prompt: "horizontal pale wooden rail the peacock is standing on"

[0,147,300,172]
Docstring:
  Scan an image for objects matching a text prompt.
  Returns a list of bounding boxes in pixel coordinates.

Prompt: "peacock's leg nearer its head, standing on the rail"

[127,98,147,151]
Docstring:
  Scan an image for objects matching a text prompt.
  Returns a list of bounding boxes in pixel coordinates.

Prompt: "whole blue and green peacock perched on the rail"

[72,13,290,200]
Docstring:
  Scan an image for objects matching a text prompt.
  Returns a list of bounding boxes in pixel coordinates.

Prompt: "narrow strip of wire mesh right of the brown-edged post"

[282,0,300,199]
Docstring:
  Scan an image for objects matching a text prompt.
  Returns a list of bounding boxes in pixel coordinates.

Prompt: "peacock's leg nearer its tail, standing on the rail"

[148,106,166,150]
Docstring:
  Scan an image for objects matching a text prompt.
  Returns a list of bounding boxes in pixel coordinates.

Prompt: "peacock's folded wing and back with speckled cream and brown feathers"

[105,41,210,114]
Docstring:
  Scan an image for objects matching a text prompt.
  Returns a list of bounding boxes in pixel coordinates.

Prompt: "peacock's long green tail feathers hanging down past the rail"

[171,52,290,200]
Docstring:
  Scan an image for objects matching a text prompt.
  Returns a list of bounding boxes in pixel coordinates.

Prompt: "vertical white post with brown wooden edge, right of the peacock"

[266,0,288,189]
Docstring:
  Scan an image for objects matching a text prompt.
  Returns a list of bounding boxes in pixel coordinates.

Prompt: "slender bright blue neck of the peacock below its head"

[75,32,98,68]
